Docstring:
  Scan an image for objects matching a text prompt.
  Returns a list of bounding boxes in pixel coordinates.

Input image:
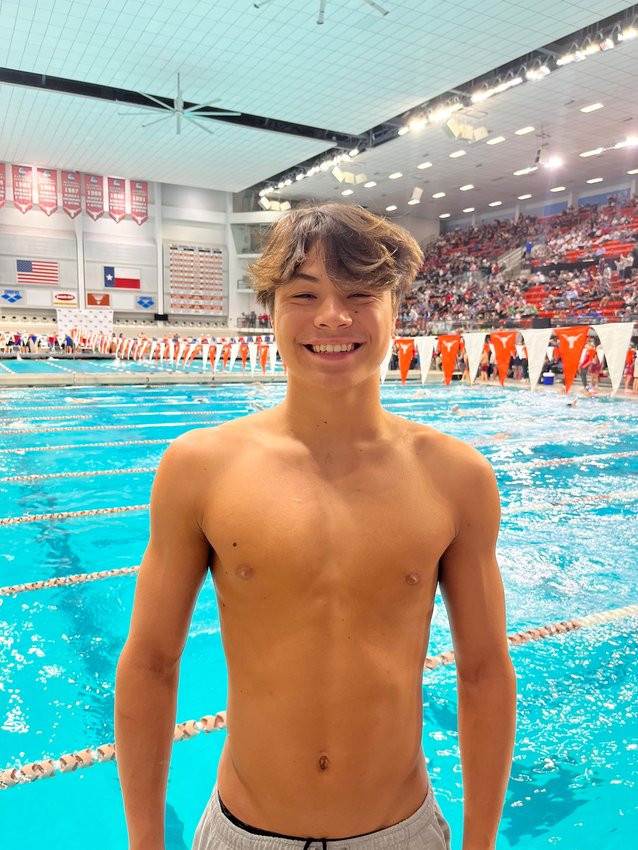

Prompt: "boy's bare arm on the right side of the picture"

[440,447,516,850]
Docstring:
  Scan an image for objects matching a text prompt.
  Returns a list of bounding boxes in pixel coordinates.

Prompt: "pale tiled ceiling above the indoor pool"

[0,0,638,212]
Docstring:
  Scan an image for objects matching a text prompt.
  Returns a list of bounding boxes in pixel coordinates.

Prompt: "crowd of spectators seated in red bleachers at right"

[397,196,638,335]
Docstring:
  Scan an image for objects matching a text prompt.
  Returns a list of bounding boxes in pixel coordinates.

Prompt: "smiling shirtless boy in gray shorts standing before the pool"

[116,204,515,850]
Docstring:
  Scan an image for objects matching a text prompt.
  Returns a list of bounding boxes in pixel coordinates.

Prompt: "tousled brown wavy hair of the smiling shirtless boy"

[249,204,423,314]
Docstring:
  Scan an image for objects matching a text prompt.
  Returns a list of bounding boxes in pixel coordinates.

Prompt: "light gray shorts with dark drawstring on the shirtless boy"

[192,785,450,850]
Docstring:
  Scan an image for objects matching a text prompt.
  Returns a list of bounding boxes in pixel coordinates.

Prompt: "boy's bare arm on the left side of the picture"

[115,432,209,850]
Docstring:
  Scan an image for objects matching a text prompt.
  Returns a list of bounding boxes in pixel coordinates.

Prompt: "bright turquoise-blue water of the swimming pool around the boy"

[0,385,638,850]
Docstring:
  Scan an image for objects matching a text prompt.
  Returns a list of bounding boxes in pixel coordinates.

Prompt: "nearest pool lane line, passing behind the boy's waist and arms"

[0,605,638,790]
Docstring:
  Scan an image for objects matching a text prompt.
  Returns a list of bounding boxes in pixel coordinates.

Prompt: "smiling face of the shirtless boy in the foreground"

[273,246,395,388]
